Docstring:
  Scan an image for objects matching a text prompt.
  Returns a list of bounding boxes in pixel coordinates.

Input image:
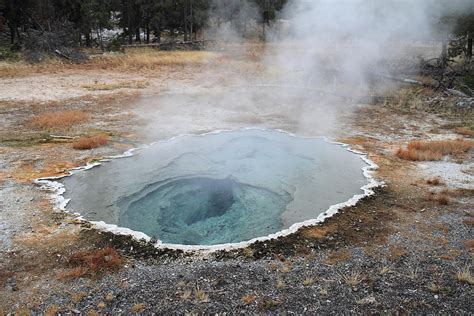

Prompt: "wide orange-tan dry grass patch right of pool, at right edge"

[396,139,474,161]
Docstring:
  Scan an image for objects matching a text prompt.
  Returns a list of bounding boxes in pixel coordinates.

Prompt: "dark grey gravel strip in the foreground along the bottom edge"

[29,235,474,314]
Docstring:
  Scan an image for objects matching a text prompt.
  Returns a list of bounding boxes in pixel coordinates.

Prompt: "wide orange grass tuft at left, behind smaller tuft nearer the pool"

[29,111,89,129]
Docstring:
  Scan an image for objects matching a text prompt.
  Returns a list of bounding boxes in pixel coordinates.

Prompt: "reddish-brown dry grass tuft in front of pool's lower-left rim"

[58,247,123,280]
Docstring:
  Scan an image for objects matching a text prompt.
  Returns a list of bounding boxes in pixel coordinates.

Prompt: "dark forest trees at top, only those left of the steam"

[0,0,286,47]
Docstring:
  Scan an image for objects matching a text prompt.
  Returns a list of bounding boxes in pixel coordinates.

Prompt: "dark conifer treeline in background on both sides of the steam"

[0,0,474,58]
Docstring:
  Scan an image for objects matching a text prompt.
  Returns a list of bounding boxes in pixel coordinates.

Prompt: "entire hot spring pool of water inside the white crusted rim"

[61,130,368,245]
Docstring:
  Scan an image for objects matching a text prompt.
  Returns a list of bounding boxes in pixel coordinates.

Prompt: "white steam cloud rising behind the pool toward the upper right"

[139,0,474,136]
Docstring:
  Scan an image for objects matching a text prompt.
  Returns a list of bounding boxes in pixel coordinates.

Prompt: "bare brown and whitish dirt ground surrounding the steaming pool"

[0,49,474,315]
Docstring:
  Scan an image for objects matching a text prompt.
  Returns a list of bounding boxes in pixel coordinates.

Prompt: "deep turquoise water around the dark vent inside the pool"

[119,177,291,245]
